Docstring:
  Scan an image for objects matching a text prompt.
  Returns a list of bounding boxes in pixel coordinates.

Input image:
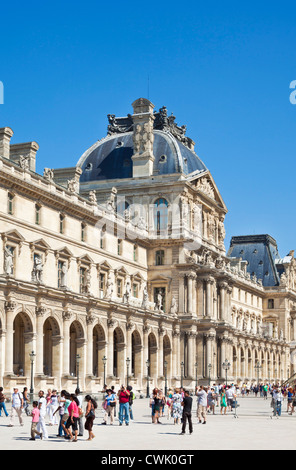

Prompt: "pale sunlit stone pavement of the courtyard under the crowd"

[0,397,296,451]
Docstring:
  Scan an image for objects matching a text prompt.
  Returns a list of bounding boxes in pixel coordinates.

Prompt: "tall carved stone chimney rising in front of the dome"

[132,98,154,178]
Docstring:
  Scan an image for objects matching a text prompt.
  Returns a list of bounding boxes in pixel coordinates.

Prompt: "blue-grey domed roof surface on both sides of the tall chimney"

[77,129,207,183]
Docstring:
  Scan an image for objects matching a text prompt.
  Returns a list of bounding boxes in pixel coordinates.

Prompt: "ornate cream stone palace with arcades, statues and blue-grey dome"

[0,98,296,393]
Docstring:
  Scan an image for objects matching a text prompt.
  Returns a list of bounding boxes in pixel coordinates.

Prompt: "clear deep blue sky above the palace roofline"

[0,0,296,256]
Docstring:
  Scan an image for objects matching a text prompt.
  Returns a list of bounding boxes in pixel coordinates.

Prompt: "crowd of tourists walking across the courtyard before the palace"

[0,383,296,442]
